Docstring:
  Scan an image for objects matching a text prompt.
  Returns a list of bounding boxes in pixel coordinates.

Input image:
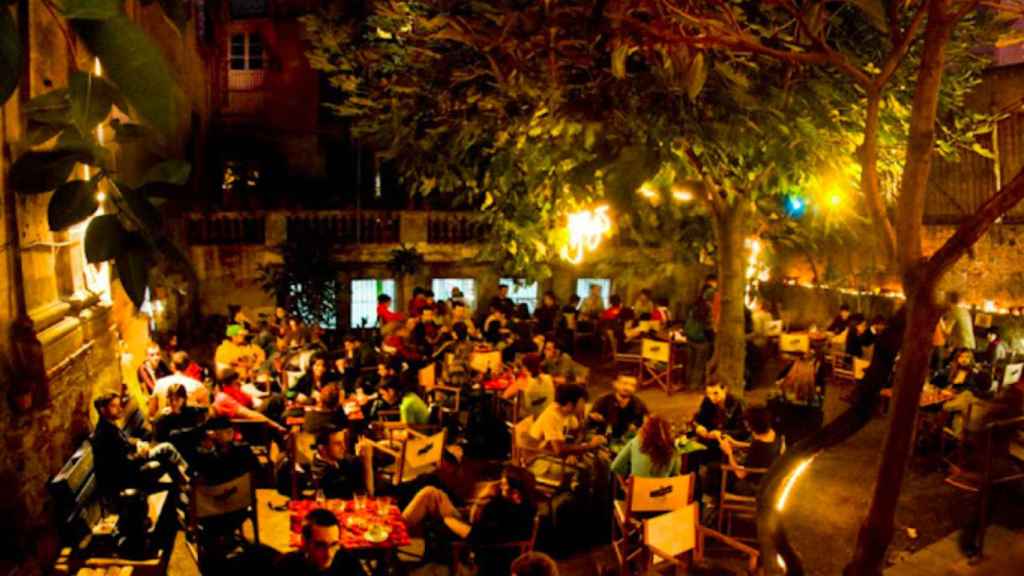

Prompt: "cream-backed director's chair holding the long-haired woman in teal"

[611,474,693,574]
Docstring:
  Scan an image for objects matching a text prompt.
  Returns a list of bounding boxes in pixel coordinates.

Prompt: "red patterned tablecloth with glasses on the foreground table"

[288,498,409,550]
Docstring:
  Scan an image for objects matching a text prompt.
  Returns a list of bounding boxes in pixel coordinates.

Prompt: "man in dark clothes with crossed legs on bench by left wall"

[89,393,188,497]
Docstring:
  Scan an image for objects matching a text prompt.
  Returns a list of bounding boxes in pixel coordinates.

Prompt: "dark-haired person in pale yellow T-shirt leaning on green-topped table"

[521,384,606,457]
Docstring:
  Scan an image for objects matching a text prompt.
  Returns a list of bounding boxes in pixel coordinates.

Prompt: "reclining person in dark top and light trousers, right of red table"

[401,465,537,574]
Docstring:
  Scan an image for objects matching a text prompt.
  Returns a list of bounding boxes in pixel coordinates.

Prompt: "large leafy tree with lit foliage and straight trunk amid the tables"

[306,0,860,395]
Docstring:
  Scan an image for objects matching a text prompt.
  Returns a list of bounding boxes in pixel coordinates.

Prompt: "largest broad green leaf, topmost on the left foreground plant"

[72,15,184,134]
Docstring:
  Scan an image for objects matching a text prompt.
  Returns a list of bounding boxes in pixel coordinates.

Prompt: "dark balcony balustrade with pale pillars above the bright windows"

[185,210,487,246]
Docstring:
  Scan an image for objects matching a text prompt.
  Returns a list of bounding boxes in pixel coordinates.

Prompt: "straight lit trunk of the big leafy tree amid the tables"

[712,198,750,398]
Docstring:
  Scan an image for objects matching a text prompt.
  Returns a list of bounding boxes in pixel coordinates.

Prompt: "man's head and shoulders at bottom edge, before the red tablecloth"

[273,508,367,576]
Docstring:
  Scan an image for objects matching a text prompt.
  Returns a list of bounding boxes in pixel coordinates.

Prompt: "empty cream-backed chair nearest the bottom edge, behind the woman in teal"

[643,502,761,574]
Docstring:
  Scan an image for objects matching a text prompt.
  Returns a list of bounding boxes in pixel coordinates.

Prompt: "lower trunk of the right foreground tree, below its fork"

[844,276,941,576]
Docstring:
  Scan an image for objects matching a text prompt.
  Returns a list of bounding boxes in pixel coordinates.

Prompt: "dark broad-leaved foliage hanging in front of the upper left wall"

[0,0,195,306]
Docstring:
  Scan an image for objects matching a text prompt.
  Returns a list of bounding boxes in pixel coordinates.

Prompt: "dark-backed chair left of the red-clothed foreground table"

[188,472,259,562]
